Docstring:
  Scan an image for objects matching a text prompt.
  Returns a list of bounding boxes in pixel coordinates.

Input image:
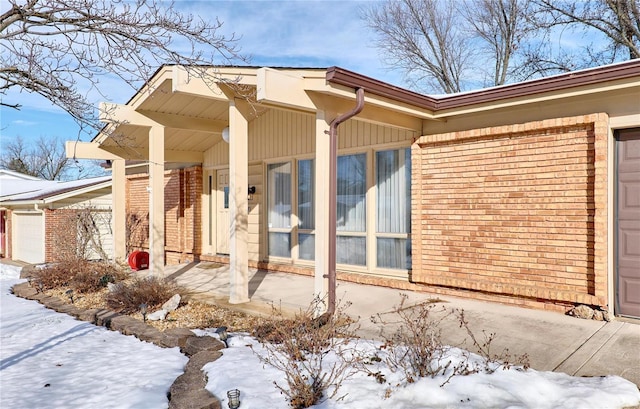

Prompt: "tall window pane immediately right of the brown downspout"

[336,153,367,266]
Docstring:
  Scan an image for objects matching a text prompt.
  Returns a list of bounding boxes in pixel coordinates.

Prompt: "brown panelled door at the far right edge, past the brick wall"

[616,128,640,318]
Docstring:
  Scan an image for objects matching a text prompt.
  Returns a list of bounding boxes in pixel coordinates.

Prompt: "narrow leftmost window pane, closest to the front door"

[267,162,291,257]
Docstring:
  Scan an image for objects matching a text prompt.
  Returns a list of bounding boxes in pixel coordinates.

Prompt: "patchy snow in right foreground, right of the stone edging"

[199,331,640,409]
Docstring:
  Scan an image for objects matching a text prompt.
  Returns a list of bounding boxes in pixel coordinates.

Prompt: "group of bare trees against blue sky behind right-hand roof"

[363,0,640,93]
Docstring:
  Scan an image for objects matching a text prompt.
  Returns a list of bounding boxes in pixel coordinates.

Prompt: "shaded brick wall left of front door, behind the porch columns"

[125,166,202,264]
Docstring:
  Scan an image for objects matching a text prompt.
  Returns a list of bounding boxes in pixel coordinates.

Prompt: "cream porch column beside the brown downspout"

[313,110,331,313]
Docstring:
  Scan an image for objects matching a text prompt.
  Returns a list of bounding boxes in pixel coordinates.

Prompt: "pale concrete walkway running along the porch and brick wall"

[166,262,640,385]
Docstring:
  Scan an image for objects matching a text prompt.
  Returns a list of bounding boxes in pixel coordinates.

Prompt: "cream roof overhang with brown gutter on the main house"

[76,60,640,163]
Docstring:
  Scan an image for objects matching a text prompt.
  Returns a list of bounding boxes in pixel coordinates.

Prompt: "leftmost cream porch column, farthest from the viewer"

[111,159,127,261]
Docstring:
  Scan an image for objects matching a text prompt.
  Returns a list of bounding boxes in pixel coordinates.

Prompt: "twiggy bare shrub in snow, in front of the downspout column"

[253,300,360,409]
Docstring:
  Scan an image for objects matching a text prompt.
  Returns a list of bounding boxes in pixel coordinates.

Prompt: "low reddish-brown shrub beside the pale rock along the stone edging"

[106,276,184,314]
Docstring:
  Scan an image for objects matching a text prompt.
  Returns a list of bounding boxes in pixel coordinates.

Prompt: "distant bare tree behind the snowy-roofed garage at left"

[0,137,99,180]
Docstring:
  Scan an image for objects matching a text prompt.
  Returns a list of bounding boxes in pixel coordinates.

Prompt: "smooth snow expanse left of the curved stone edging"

[0,264,187,409]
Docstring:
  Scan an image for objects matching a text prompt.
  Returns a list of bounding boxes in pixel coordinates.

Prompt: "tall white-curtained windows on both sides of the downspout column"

[267,148,411,271]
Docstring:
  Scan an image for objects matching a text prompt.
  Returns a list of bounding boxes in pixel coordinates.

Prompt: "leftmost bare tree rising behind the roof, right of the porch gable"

[362,0,473,93]
